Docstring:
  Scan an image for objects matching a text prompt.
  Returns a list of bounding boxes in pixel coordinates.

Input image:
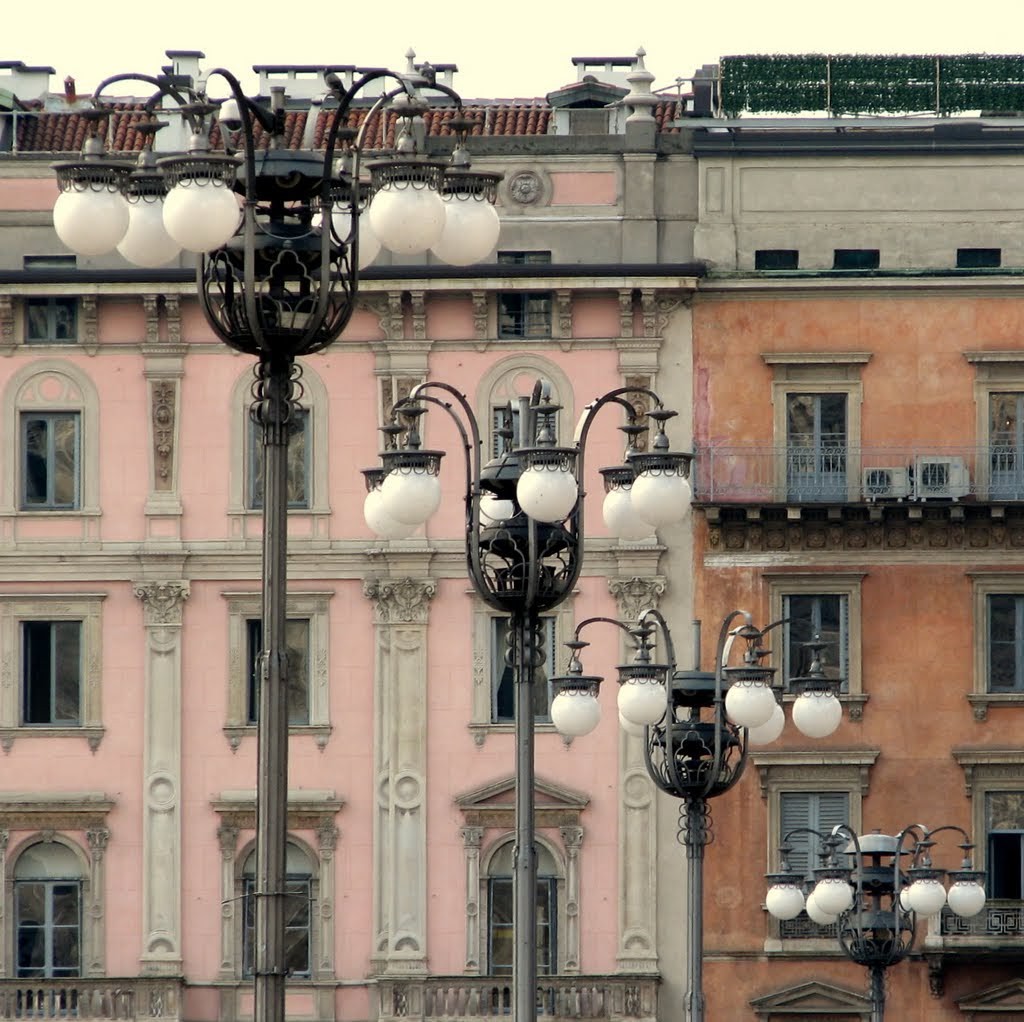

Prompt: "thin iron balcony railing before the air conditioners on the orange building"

[693,443,1024,504]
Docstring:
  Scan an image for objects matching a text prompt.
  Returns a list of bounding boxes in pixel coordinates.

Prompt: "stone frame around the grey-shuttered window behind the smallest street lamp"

[750,748,881,955]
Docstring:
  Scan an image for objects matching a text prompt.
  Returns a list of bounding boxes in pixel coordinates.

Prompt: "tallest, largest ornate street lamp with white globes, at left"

[53,54,501,1022]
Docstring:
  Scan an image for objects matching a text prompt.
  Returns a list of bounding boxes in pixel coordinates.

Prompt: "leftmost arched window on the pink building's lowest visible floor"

[14,842,83,979]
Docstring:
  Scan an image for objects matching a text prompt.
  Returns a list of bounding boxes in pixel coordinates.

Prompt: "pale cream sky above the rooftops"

[8,0,1024,98]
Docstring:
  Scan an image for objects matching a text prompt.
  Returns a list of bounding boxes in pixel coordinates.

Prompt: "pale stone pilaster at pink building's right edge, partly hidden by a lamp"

[608,577,665,973]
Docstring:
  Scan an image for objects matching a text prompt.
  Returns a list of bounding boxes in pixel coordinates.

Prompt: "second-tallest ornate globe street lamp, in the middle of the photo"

[365,381,692,1022]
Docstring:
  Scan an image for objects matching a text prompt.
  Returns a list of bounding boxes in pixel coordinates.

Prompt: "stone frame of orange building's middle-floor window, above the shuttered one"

[762,571,868,721]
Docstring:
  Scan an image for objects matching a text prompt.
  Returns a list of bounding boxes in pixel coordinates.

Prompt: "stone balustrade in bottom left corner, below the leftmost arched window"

[0,978,180,1022]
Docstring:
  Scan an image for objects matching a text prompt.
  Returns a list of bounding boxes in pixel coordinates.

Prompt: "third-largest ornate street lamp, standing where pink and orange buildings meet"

[551,609,843,1022]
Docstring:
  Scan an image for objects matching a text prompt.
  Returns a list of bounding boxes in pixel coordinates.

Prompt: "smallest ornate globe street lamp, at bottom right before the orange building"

[765,823,985,1022]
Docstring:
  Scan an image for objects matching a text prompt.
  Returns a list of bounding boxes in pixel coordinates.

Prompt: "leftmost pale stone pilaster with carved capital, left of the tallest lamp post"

[134,581,188,975]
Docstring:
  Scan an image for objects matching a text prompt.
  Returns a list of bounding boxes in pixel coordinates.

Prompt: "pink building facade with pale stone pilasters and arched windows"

[0,54,698,1022]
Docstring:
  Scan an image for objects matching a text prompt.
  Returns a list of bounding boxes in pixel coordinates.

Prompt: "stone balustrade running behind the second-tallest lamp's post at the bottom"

[378,975,657,1022]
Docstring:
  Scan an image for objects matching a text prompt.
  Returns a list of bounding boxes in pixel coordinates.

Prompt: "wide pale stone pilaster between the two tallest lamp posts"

[362,578,437,974]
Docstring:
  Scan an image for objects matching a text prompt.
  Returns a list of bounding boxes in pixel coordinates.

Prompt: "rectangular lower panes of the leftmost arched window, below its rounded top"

[14,880,82,978]
